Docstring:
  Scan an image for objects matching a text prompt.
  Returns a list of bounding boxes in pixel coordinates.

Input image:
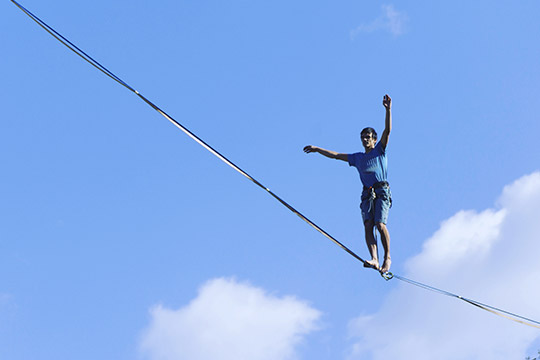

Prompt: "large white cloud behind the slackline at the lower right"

[349,172,540,360]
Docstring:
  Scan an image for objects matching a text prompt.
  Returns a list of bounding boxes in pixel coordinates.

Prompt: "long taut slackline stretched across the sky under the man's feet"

[11,0,540,329]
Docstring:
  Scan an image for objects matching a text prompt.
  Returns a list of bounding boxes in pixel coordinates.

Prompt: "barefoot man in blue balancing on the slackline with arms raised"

[304,95,392,274]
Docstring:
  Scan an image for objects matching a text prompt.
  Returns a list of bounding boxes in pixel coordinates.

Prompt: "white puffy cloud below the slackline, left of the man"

[141,278,321,360]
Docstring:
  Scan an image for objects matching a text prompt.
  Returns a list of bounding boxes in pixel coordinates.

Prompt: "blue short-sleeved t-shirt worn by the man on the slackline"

[347,142,388,187]
